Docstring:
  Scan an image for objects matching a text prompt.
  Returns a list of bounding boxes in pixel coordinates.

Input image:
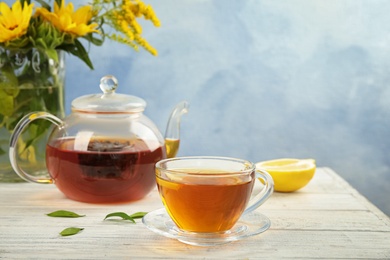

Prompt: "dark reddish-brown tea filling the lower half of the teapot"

[46,138,166,203]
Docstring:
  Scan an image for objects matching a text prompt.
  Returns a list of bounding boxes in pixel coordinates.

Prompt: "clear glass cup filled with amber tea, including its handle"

[156,157,273,233]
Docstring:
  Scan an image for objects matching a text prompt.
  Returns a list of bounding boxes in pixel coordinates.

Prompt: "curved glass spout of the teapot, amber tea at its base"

[165,101,189,158]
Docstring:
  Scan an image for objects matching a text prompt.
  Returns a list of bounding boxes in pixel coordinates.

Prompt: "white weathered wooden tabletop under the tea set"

[0,168,390,259]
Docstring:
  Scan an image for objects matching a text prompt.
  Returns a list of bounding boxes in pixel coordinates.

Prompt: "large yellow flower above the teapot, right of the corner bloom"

[35,0,99,37]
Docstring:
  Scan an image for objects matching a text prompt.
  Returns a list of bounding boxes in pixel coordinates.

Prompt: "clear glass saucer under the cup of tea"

[142,208,271,246]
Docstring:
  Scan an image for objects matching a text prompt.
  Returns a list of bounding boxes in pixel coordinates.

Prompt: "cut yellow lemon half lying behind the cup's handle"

[256,158,316,192]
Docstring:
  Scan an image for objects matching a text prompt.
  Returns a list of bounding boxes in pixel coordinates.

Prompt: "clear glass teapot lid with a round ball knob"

[72,75,146,113]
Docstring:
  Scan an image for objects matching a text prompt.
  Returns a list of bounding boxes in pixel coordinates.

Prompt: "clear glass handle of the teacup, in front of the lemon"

[243,169,274,215]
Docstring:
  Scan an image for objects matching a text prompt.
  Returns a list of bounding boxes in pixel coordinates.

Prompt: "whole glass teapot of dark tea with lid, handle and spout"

[9,76,188,203]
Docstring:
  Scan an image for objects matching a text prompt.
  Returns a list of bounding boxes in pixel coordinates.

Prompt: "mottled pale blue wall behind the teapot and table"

[8,0,390,215]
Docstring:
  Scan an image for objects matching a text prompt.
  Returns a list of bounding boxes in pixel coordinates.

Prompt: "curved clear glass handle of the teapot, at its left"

[9,112,63,184]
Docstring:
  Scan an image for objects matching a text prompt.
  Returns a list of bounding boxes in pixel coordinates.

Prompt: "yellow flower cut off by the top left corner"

[0,1,34,42]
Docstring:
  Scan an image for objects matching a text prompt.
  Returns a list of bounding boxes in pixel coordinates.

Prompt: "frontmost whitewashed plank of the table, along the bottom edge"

[0,230,390,259]
